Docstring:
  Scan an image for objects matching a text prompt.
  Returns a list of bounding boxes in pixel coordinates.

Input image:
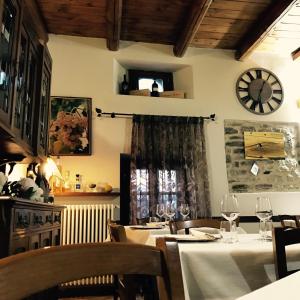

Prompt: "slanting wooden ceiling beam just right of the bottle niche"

[173,0,212,57]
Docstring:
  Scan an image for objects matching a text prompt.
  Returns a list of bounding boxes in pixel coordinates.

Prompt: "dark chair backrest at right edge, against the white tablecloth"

[273,227,300,279]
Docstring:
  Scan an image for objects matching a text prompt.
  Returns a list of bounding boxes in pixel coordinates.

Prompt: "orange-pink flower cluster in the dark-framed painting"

[49,105,89,154]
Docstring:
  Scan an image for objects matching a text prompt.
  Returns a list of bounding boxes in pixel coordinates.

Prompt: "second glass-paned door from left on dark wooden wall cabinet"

[13,27,29,138]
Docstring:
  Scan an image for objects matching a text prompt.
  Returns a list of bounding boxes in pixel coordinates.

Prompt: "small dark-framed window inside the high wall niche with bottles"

[128,70,174,92]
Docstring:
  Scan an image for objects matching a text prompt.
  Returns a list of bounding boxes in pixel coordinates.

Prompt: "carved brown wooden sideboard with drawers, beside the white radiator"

[0,196,64,258]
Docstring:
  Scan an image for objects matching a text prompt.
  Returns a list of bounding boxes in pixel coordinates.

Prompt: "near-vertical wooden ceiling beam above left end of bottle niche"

[106,0,123,51]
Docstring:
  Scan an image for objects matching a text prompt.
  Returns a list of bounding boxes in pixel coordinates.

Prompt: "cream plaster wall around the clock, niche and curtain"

[48,35,300,215]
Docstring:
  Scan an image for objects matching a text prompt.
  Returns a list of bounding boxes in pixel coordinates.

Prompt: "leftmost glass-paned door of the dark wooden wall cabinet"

[0,0,20,128]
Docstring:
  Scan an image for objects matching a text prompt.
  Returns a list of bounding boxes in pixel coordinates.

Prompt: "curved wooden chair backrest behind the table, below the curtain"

[169,219,221,234]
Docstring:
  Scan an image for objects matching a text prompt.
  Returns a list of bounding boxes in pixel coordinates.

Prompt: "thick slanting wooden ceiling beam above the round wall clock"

[235,0,298,60]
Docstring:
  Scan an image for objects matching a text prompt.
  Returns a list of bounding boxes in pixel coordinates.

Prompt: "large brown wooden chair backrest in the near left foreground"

[0,238,184,300]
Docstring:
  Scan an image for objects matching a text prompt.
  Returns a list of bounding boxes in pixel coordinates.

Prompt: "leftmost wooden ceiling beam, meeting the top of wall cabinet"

[24,0,49,44]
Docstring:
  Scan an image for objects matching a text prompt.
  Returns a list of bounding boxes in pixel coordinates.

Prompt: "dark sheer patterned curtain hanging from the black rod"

[130,116,211,224]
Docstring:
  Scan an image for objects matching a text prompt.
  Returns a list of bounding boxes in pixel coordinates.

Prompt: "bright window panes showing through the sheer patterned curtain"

[136,169,177,219]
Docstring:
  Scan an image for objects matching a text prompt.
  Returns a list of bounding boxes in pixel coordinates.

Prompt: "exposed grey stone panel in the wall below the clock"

[224,120,300,193]
